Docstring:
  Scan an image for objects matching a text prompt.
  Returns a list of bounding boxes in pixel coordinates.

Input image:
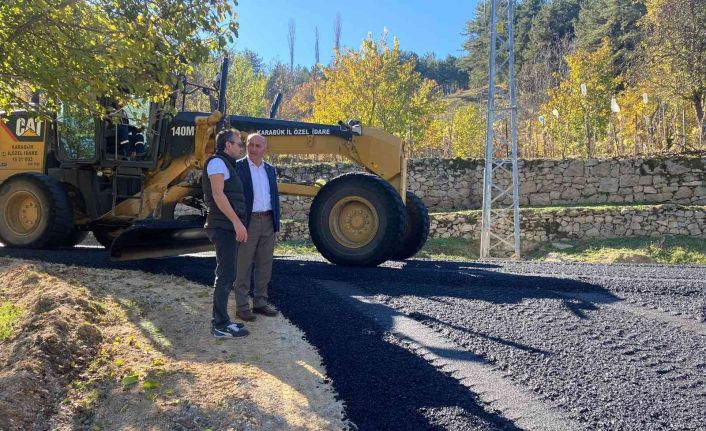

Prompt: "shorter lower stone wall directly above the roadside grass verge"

[280,204,706,249]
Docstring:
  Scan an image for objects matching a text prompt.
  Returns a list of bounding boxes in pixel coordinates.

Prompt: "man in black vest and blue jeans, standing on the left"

[201,129,248,338]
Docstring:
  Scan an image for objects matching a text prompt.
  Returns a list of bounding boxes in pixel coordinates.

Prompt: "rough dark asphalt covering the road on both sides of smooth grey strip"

[0,249,706,430]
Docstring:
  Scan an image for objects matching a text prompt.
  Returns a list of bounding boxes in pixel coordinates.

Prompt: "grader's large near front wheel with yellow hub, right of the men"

[309,173,405,266]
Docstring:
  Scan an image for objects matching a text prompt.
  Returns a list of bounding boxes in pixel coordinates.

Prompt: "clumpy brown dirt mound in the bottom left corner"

[0,260,102,430]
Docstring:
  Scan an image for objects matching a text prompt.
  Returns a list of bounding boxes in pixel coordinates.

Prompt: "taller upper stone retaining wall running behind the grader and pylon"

[278,157,706,219]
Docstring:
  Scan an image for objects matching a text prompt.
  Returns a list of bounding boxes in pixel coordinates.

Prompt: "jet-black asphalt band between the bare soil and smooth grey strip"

[270,260,518,431]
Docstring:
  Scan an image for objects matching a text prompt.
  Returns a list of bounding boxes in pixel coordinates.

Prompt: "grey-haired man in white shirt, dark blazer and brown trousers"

[235,133,280,321]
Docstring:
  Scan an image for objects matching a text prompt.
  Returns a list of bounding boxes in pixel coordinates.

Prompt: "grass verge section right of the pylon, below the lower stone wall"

[524,236,706,265]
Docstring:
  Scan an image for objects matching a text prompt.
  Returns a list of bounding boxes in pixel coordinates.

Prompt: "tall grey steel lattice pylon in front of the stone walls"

[480,0,520,259]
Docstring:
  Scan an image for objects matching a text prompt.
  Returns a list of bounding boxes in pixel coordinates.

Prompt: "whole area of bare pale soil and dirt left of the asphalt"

[0,258,348,431]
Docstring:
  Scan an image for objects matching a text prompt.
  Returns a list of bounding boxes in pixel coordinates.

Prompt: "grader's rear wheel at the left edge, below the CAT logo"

[0,173,73,248]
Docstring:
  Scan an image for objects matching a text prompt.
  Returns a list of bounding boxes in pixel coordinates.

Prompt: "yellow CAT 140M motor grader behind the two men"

[0,58,429,266]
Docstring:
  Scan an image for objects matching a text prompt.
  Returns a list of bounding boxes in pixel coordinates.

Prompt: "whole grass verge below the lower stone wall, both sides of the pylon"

[275,236,706,265]
